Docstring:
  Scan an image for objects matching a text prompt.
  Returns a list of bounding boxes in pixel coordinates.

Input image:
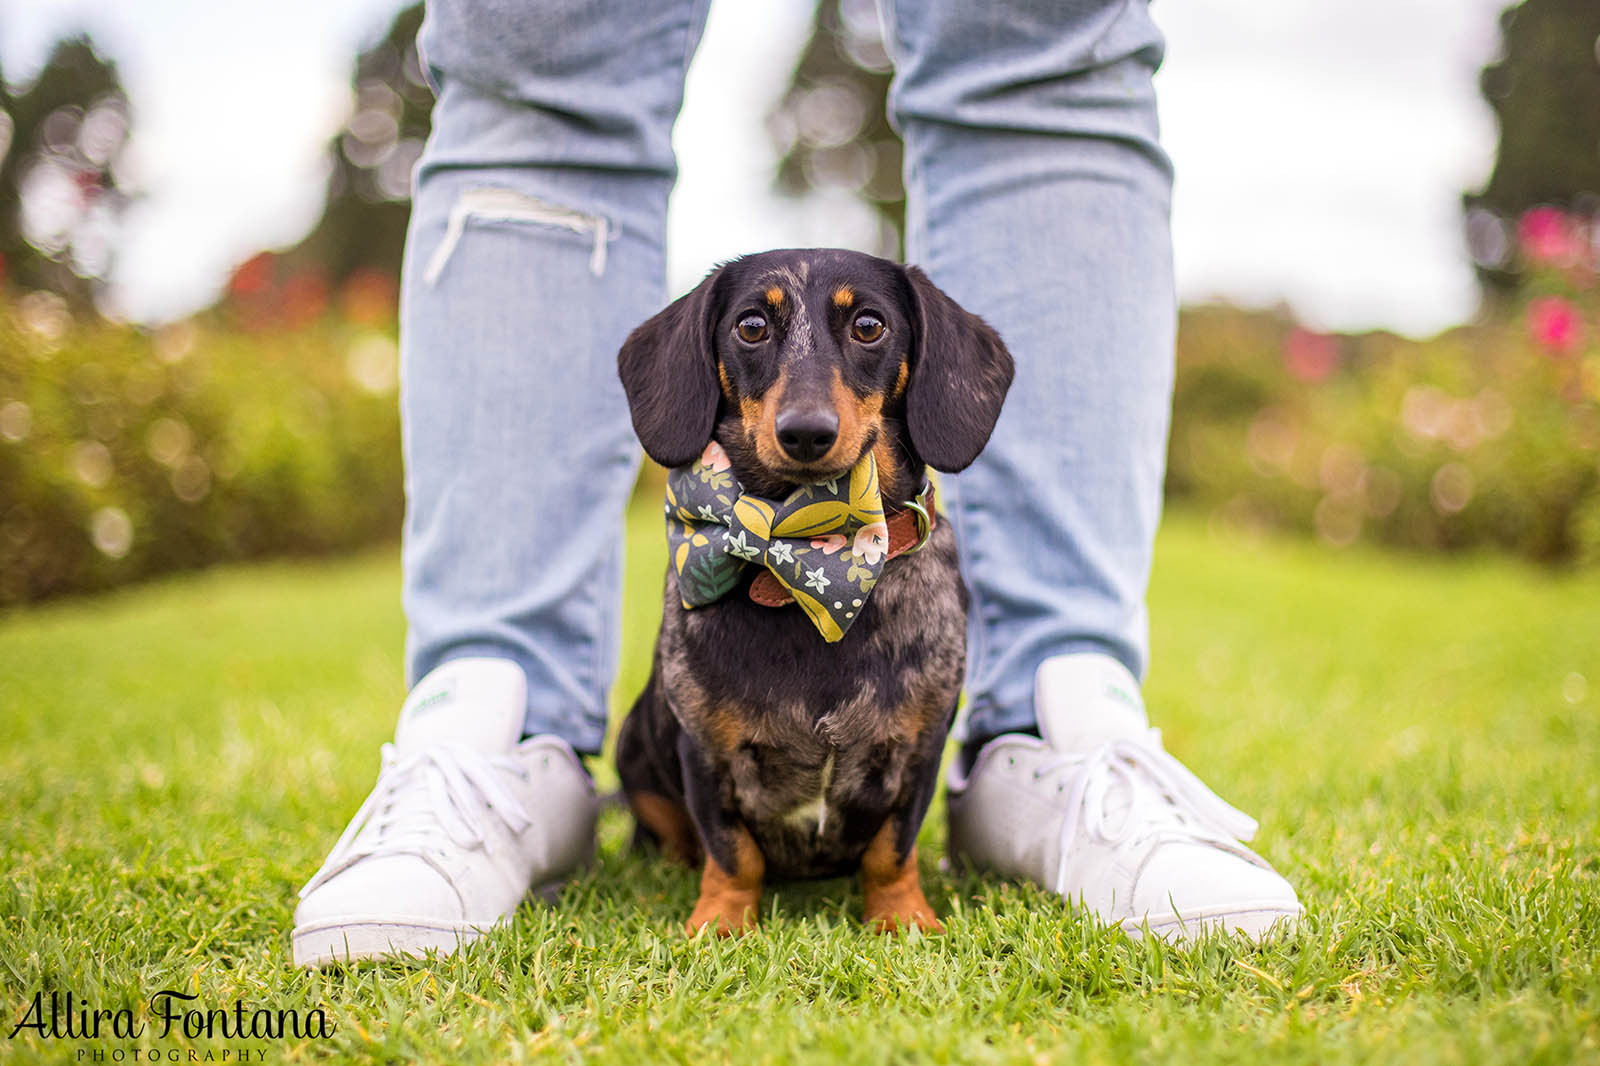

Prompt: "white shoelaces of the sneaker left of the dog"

[299,744,531,898]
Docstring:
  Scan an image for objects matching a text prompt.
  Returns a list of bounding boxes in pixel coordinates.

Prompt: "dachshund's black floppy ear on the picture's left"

[616,271,722,467]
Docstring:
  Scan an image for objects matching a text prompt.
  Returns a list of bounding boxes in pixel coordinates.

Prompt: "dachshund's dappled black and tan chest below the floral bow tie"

[658,523,965,877]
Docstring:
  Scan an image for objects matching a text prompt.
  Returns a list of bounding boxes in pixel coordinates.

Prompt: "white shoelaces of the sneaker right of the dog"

[1034,728,1256,895]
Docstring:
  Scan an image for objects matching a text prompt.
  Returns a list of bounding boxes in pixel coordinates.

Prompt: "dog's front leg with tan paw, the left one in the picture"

[678,733,766,936]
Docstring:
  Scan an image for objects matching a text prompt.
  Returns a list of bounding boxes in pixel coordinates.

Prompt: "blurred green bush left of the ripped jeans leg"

[0,293,403,603]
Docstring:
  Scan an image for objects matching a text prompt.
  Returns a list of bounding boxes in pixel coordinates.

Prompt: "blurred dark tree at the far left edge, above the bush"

[0,35,131,307]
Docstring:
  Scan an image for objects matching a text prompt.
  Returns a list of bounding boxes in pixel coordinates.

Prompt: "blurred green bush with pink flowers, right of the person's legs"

[1168,208,1600,565]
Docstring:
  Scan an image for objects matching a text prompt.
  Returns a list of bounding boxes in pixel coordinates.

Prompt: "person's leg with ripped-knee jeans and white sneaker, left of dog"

[291,0,706,965]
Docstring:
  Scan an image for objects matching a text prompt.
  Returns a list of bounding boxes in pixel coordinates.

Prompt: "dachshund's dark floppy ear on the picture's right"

[906,267,1013,474]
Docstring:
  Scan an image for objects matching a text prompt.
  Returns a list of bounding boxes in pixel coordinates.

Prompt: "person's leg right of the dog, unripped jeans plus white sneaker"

[888,0,1301,936]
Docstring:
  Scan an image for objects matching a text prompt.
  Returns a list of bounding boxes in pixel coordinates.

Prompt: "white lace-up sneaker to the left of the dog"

[293,658,598,967]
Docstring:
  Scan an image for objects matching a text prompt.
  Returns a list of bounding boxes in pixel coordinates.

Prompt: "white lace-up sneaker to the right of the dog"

[949,653,1304,940]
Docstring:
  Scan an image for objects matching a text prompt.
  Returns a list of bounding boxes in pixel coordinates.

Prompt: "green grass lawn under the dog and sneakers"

[0,507,1600,1066]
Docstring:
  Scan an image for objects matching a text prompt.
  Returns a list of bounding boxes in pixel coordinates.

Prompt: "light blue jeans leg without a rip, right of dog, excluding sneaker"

[886,0,1176,738]
